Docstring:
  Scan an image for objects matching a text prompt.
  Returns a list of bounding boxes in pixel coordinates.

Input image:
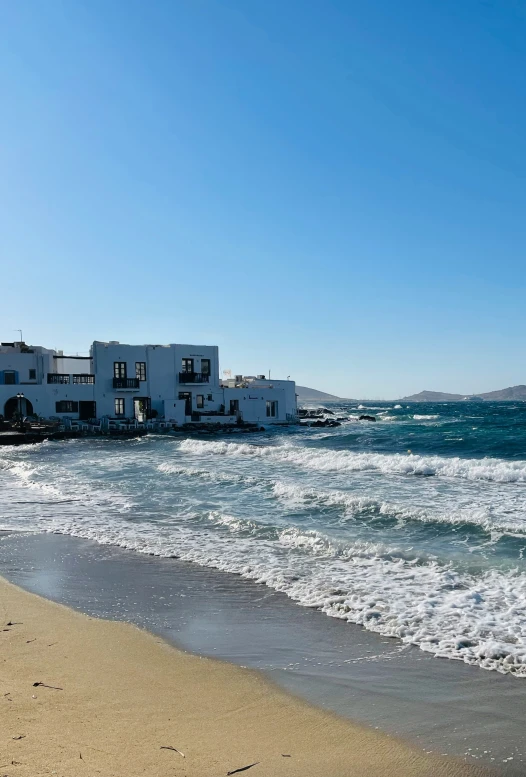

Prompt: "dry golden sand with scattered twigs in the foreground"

[0,578,496,777]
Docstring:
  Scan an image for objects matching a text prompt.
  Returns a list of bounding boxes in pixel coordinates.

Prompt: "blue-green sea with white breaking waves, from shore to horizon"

[0,402,526,678]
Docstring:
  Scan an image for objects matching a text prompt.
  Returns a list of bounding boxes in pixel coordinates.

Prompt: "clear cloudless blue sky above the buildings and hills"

[0,0,526,398]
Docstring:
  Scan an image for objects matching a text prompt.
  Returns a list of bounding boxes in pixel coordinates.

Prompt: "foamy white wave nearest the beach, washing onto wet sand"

[29,511,526,677]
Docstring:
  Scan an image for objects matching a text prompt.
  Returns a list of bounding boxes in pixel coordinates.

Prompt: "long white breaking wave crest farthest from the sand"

[180,440,526,483]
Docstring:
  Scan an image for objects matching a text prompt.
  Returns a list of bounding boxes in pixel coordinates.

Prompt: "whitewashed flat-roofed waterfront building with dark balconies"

[0,341,296,425]
